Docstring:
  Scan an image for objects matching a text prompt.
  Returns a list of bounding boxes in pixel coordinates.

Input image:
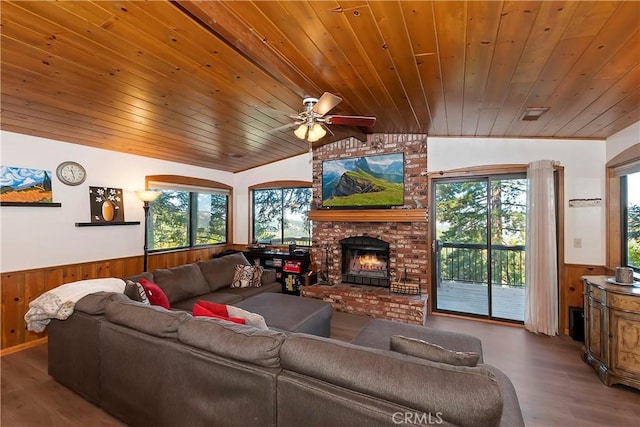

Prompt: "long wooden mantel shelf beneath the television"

[309,209,427,222]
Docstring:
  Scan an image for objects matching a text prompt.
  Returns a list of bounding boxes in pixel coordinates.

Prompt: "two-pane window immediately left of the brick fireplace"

[252,187,311,246]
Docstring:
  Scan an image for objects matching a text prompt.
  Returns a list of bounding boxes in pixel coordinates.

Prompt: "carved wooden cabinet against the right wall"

[582,276,640,389]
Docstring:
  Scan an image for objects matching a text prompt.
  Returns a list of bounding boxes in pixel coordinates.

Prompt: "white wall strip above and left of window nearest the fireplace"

[233,153,313,245]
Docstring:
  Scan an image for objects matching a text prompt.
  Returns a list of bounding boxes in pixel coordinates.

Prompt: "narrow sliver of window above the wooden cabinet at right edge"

[620,172,640,272]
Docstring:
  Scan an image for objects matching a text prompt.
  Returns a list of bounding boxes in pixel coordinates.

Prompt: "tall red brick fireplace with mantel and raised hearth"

[301,134,429,323]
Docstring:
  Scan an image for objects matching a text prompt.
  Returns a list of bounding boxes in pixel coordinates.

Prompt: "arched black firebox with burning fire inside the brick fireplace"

[340,237,391,288]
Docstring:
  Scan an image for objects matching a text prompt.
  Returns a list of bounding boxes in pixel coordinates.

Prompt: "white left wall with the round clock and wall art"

[0,131,233,272]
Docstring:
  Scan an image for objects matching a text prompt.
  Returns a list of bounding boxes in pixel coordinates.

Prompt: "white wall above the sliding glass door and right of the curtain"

[427,138,606,265]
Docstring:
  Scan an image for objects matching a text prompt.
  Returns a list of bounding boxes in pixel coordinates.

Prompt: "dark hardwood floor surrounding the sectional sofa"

[0,312,640,427]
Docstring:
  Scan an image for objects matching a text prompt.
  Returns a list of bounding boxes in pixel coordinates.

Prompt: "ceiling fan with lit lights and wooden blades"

[269,92,376,142]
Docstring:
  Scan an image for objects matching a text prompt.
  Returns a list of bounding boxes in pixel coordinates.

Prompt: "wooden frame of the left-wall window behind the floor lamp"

[145,175,233,254]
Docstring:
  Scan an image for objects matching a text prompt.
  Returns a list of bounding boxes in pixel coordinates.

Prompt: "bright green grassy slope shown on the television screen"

[322,170,404,207]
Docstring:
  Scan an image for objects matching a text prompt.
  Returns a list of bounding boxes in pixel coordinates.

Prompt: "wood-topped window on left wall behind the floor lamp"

[147,176,230,251]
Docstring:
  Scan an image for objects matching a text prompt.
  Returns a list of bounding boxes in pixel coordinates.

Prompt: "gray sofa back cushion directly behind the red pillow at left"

[153,264,209,303]
